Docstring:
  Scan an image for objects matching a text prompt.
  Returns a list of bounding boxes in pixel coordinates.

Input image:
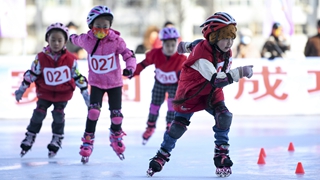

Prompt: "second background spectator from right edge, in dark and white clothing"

[261,22,290,60]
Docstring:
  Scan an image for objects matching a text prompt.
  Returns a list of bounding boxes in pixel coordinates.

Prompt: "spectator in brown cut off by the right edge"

[304,19,320,56]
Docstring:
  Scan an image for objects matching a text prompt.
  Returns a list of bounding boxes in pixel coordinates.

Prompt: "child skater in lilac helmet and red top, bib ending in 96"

[134,27,187,144]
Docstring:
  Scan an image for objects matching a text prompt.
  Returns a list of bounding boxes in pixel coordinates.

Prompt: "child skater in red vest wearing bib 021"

[15,23,90,158]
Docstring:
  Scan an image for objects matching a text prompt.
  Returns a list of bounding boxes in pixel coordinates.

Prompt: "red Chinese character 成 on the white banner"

[235,66,288,100]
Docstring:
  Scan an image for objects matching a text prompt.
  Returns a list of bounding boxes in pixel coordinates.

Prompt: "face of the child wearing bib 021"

[48,31,66,53]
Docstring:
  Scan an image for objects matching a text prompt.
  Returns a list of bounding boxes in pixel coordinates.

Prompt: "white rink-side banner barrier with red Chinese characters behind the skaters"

[0,54,320,119]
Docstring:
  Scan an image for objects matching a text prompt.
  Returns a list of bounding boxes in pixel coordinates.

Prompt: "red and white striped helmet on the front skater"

[200,12,237,39]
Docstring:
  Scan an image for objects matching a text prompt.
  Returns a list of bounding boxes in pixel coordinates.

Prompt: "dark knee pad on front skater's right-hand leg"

[214,103,232,130]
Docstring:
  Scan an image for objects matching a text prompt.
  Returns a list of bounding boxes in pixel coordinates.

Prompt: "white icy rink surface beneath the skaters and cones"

[0,113,320,180]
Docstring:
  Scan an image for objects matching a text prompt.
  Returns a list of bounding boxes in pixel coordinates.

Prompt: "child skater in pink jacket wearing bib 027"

[70,6,136,163]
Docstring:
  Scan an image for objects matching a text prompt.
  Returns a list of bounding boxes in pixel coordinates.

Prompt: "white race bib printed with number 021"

[43,66,71,86]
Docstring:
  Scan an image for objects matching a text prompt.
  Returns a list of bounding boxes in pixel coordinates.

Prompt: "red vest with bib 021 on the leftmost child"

[35,51,76,102]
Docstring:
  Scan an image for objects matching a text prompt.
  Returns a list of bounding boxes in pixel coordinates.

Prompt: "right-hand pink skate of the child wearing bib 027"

[109,129,127,160]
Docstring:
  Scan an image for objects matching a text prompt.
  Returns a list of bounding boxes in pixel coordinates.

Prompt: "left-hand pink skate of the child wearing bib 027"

[79,132,94,164]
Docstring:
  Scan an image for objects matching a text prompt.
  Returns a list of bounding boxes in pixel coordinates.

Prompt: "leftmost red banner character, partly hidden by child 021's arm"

[11,71,38,104]
